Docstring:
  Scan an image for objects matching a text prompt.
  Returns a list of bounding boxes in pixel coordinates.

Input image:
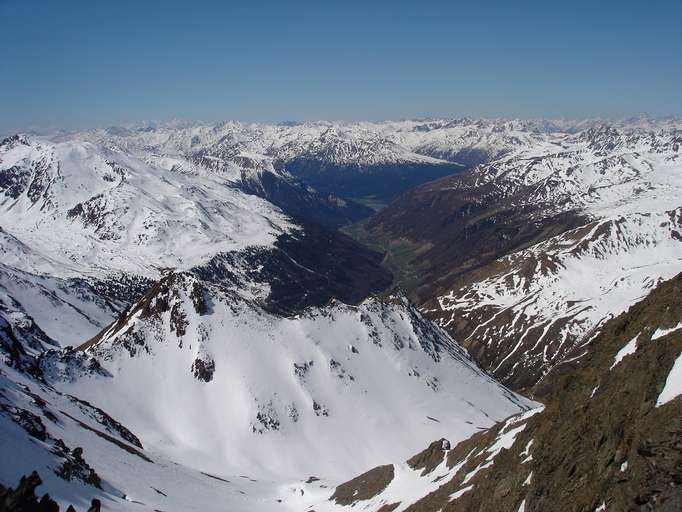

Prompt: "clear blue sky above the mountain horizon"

[0,0,682,132]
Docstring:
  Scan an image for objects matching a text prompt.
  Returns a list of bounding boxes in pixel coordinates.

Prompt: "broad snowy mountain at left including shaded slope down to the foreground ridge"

[0,136,294,345]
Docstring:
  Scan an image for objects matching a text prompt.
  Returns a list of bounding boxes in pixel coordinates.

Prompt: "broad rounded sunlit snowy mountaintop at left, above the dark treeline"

[0,138,291,276]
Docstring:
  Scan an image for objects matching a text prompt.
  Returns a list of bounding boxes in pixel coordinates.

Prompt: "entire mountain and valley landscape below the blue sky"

[0,116,682,512]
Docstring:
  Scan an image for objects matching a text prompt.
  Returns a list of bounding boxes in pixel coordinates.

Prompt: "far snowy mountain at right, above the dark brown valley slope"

[473,125,682,220]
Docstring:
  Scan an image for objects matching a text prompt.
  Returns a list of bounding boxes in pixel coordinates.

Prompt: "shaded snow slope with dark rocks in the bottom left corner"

[0,360,290,512]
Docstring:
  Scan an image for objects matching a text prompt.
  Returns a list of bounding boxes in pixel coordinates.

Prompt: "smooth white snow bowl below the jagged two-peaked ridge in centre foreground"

[44,274,528,480]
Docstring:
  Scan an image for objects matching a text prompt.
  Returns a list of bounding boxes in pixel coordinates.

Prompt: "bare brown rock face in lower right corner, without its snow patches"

[436,275,682,512]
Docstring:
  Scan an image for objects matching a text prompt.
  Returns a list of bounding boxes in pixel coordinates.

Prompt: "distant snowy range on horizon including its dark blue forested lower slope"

[65,116,680,201]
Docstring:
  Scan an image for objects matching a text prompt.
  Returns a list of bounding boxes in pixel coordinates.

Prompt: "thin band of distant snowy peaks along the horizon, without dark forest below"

[60,117,682,180]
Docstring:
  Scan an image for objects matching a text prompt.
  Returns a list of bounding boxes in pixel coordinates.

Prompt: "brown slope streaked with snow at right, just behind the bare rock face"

[437,208,682,383]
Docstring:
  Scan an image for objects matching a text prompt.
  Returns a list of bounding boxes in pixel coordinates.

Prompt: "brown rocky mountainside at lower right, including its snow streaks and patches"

[306,274,682,512]
